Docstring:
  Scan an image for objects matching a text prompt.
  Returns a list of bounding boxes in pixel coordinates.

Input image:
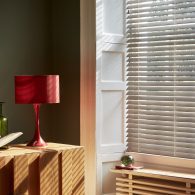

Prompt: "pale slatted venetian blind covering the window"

[126,0,195,159]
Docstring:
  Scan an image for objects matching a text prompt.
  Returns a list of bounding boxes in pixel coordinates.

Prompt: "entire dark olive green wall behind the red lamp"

[0,0,80,144]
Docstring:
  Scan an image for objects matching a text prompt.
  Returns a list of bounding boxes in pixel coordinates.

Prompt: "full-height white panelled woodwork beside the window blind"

[96,0,126,195]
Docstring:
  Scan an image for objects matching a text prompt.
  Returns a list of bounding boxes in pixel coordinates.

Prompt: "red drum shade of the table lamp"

[15,75,60,104]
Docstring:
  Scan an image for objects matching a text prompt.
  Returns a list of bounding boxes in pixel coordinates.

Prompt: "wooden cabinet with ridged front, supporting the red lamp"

[0,143,85,195]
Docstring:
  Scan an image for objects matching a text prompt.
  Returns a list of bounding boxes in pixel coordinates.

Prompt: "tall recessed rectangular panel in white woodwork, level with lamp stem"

[101,91,124,145]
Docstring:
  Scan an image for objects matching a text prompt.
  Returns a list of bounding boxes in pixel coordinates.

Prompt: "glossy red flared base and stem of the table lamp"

[28,104,47,146]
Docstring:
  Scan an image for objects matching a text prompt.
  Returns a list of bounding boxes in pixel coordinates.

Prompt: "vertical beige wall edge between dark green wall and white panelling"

[80,0,97,194]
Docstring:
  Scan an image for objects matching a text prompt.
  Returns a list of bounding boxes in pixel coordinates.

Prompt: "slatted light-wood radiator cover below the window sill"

[111,169,195,195]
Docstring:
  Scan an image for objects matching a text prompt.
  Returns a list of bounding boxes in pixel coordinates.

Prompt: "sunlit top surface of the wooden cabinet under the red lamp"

[0,143,82,157]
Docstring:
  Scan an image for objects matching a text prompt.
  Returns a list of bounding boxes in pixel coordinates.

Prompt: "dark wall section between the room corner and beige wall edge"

[52,0,80,144]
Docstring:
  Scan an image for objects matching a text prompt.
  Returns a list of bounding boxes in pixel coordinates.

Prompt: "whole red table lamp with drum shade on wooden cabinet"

[15,75,60,146]
